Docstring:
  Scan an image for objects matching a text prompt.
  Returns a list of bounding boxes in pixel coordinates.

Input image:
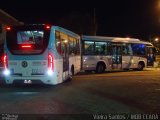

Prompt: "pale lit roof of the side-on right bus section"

[81,35,152,45]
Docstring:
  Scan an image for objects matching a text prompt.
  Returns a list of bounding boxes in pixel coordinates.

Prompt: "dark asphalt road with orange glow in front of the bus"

[0,70,160,114]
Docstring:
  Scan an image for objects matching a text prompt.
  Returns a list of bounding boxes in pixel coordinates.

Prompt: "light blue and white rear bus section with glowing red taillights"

[3,25,81,85]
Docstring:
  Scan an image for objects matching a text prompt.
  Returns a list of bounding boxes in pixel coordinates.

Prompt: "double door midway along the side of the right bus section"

[112,43,122,69]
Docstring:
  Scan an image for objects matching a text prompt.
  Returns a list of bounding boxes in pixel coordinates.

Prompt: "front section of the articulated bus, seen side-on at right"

[81,35,155,73]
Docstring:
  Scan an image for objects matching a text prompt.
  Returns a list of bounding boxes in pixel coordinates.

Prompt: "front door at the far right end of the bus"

[147,46,156,66]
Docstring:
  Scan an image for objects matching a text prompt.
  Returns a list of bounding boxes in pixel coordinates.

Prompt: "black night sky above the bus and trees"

[0,0,160,40]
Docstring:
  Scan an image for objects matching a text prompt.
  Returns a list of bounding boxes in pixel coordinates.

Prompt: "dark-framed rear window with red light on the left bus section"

[7,30,48,54]
